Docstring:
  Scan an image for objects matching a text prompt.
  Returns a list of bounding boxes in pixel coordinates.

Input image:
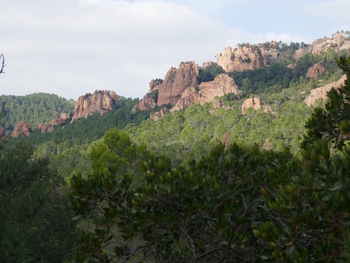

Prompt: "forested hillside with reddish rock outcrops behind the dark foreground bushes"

[4,34,350,160]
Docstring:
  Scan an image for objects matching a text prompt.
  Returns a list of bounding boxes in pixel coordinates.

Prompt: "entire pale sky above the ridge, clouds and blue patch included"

[0,0,350,100]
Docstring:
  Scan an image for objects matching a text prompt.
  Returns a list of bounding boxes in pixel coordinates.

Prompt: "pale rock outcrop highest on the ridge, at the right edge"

[294,34,350,59]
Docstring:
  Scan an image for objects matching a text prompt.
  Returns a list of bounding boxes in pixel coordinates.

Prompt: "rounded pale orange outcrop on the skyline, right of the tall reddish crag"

[215,44,278,72]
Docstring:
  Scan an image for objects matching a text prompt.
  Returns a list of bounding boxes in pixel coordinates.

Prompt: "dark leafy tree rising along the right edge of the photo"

[255,55,350,262]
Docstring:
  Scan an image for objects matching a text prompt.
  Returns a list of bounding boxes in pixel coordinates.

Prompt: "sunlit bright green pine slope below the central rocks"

[125,95,312,162]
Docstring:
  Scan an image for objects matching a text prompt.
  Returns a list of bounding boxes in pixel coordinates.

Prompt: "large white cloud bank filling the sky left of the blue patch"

[0,0,328,99]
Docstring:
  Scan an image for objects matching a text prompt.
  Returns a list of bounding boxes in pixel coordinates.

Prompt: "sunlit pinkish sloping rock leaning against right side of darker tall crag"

[170,74,241,112]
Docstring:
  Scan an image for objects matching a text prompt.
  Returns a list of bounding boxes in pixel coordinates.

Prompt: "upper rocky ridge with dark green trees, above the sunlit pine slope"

[133,34,350,119]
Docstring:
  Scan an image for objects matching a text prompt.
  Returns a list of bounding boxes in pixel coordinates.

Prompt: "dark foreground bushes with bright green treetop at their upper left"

[70,127,297,262]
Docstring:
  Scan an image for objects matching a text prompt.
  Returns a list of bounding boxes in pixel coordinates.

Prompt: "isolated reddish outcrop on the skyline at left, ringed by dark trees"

[72,90,119,122]
